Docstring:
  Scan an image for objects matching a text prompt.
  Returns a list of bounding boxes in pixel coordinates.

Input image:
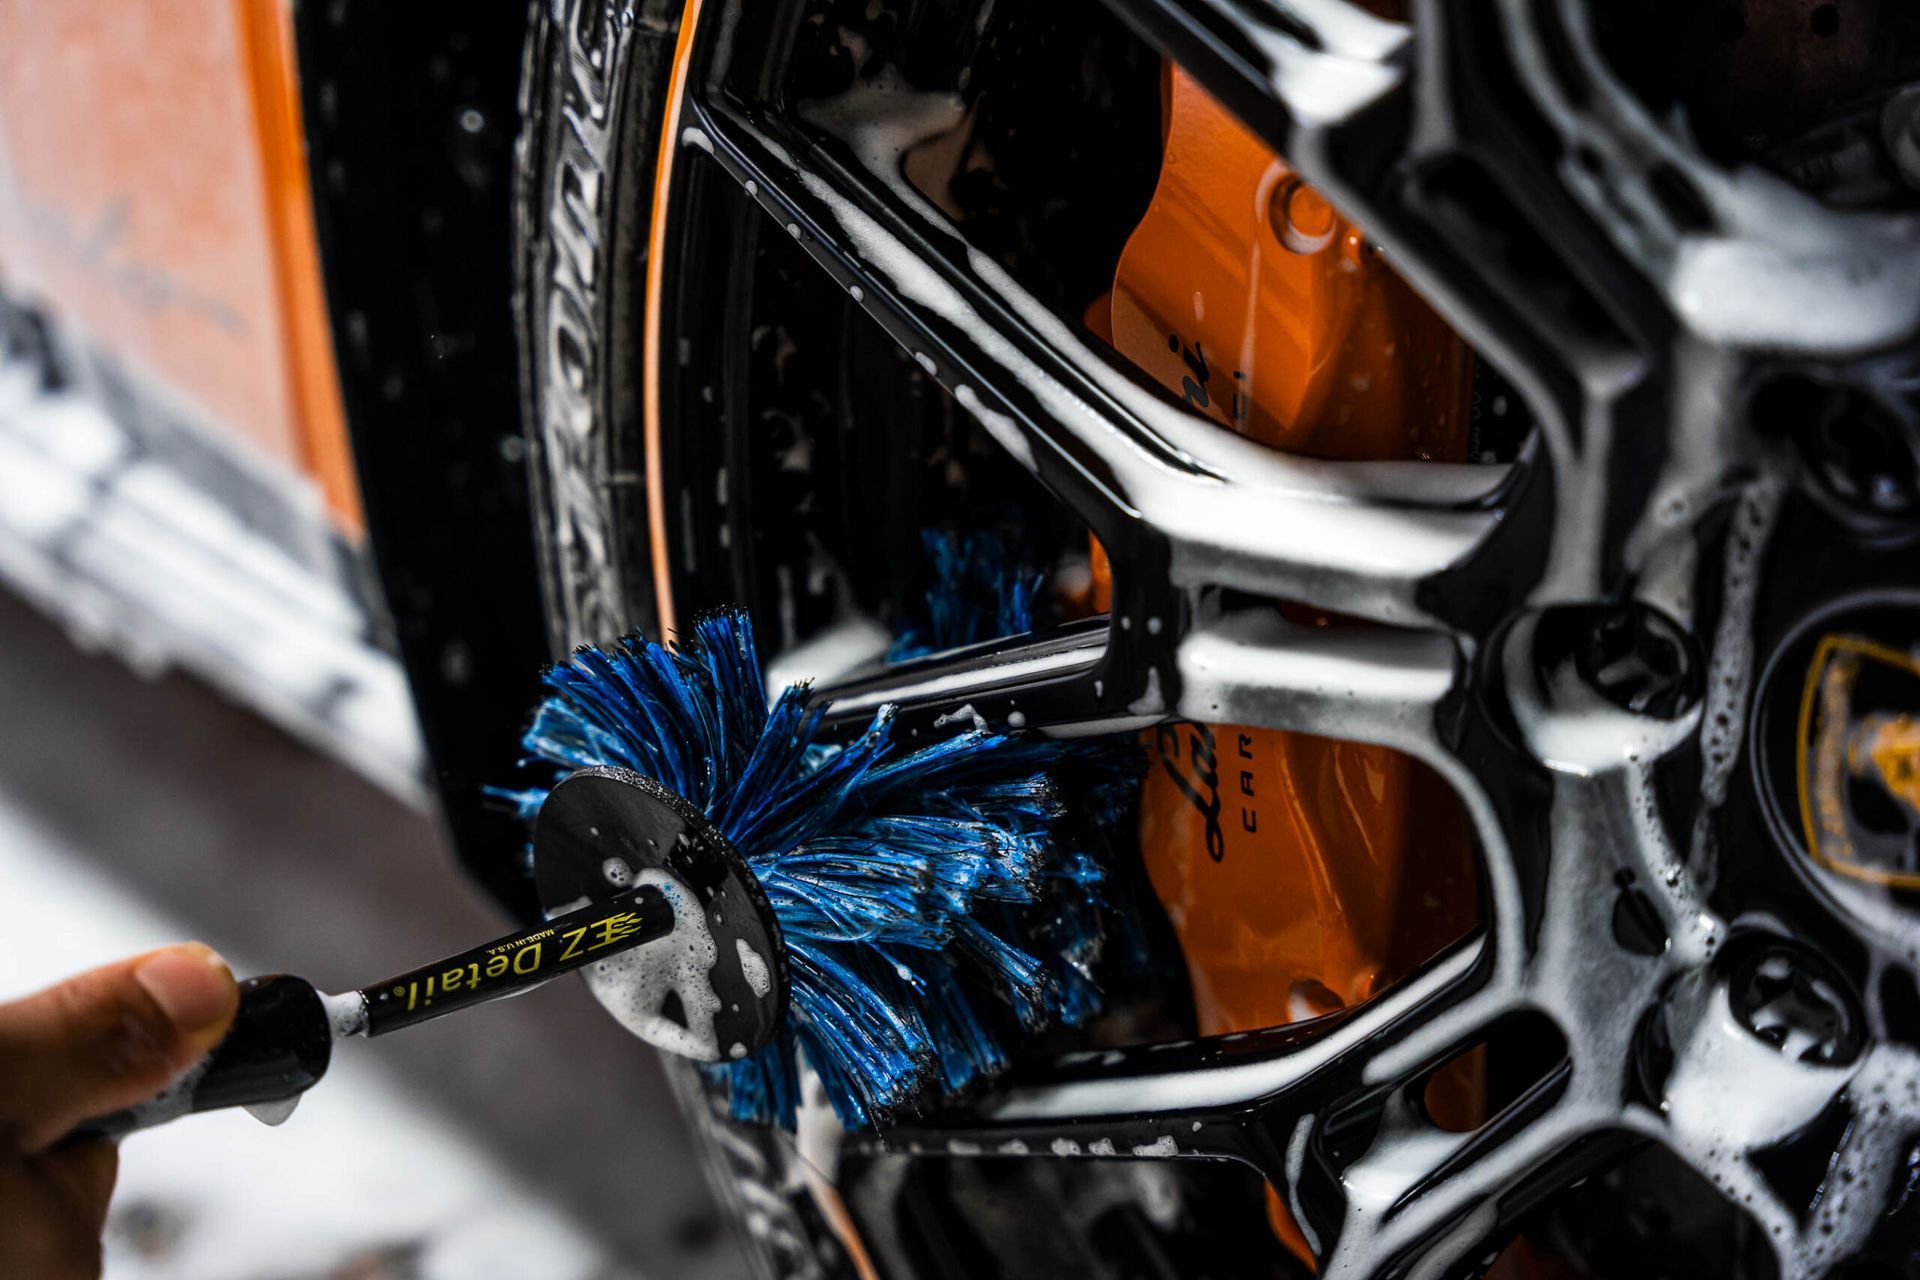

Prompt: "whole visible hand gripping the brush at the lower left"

[0,942,240,1280]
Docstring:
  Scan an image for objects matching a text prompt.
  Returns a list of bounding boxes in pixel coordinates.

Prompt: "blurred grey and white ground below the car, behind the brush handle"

[0,595,745,1280]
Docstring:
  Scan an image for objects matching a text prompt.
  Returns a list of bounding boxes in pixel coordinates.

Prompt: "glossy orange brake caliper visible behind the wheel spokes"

[1092,69,1480,1261]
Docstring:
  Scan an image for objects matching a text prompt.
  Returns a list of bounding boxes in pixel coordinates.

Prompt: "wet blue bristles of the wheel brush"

[493,614,1139,1126]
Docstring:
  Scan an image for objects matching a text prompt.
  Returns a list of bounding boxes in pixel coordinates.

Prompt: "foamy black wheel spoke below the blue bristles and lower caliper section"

[849,924,1638,1276]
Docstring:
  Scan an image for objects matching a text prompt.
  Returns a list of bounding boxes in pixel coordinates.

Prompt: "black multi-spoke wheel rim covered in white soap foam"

[579,0,1920,1274]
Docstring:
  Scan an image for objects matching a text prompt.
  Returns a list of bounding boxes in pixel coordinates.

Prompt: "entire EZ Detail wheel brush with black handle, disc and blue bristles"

[69,614,1137,1140]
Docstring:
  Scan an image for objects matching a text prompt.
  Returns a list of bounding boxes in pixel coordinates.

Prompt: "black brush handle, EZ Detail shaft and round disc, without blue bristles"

[63,770,787,1142]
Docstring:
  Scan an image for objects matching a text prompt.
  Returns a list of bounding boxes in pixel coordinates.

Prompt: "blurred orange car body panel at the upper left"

[0,0,361,532]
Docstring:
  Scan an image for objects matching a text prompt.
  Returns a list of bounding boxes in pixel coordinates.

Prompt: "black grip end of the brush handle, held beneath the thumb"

[61,973,334,1146]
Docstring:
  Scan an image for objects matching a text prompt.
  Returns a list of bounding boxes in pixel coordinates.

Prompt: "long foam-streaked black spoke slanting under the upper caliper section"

[687,96,1507,622]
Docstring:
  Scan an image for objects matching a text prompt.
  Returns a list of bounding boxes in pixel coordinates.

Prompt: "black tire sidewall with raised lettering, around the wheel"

[515,0,854,1278]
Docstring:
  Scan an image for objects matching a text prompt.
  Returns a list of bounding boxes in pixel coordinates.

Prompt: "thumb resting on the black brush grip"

[0,942,240,1151]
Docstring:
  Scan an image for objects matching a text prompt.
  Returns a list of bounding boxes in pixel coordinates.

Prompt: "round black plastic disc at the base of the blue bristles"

[534,766,787,1061]
